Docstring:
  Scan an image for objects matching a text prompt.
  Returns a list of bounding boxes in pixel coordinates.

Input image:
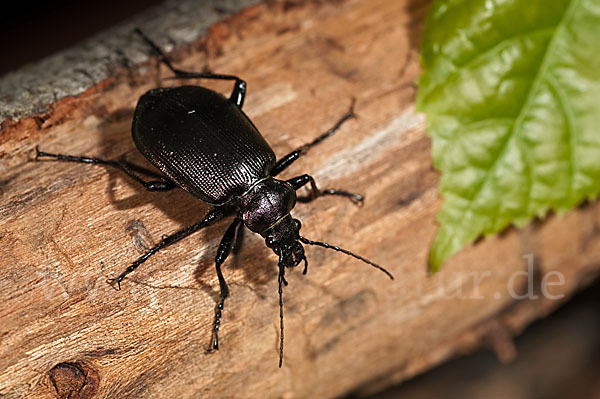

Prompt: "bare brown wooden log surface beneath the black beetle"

[0,0,600,398]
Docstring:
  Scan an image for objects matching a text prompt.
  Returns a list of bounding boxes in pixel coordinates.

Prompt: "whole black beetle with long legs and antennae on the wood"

[36,29,393,367]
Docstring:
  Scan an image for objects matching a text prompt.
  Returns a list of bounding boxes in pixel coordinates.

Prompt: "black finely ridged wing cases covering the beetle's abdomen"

[132,86,275,205]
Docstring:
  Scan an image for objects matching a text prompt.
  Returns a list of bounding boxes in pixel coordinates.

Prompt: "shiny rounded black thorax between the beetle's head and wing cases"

[239,177,296,234]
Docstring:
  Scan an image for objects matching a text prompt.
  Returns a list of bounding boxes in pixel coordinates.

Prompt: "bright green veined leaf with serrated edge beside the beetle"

[417,0,600,271]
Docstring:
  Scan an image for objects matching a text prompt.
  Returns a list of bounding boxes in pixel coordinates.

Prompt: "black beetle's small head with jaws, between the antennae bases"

[263,214,306,267]
